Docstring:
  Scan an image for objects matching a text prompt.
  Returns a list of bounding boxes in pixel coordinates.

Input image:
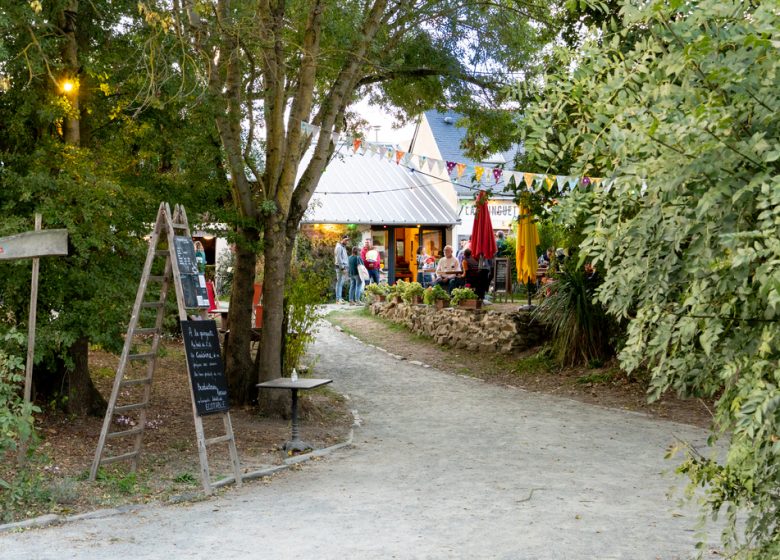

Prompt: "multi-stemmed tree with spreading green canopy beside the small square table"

[141,0,550,401]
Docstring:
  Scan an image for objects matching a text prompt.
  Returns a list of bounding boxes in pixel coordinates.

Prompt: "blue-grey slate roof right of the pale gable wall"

[412,110,520,197]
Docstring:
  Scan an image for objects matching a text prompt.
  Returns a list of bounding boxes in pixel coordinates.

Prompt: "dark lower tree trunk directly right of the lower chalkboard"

[225,225,265,405]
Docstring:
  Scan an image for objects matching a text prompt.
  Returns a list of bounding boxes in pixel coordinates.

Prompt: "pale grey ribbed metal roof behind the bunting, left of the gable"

[302,146,459,226]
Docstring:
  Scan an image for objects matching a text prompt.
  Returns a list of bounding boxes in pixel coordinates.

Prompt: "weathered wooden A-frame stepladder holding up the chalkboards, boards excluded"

[89,202,241,494]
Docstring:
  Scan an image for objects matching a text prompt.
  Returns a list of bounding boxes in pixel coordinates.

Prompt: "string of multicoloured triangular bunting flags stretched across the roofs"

[301,121,611,191]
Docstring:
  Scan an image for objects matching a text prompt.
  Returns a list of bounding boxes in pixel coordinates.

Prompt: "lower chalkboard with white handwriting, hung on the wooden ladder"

[181,321,230,416]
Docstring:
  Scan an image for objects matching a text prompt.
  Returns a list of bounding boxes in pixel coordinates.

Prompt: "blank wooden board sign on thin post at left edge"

[0,214,68,402]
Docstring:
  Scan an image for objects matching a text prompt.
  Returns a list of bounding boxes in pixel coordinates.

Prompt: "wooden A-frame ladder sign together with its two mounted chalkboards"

[90,202,241,494]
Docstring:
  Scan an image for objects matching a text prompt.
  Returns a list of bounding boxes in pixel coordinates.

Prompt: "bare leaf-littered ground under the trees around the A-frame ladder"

[0,340,352,523]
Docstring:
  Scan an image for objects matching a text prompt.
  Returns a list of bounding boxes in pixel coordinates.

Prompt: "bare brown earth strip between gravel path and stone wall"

[328,303,712,427]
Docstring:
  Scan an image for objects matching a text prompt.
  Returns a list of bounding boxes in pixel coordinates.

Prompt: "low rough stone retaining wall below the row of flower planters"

[370,302,549,353]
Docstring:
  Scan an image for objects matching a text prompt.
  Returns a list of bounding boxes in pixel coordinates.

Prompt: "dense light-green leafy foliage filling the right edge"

[525,0,780,558]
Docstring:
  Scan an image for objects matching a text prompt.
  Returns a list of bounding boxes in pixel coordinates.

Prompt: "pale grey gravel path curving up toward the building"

[0,318,717,560]
